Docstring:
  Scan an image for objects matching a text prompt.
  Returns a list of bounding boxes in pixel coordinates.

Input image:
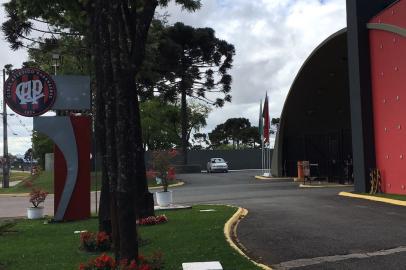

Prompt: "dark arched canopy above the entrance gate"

[272,29,351,176]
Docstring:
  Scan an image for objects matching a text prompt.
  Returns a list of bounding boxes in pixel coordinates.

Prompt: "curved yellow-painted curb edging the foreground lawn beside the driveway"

[224,207,272,270]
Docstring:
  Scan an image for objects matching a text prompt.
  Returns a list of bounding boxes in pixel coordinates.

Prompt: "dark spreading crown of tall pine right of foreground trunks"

[158,23,235,107]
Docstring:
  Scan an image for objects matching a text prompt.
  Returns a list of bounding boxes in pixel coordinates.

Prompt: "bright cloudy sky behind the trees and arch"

[0,0,346,155]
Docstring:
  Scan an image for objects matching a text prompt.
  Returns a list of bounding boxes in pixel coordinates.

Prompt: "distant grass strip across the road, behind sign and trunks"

[0,171,179,194]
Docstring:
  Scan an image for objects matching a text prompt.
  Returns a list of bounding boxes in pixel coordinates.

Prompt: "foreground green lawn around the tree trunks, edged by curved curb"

[0,205,260,270]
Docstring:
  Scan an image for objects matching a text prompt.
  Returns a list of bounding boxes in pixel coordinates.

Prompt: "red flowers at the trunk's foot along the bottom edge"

[79,253,163,270]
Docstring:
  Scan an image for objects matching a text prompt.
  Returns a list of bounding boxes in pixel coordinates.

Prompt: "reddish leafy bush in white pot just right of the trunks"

[147,149,178,192]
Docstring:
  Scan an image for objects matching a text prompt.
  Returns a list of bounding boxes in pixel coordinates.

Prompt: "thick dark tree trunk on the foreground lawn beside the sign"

[89,0,158,261]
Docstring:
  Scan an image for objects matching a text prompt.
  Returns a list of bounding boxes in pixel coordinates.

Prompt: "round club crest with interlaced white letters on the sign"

[4,68,56,117]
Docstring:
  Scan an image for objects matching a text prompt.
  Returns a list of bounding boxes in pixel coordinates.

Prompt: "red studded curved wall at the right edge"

[370,0,406,194]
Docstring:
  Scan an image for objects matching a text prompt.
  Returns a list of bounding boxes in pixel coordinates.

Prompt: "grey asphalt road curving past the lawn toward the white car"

[0,171,406,270]
